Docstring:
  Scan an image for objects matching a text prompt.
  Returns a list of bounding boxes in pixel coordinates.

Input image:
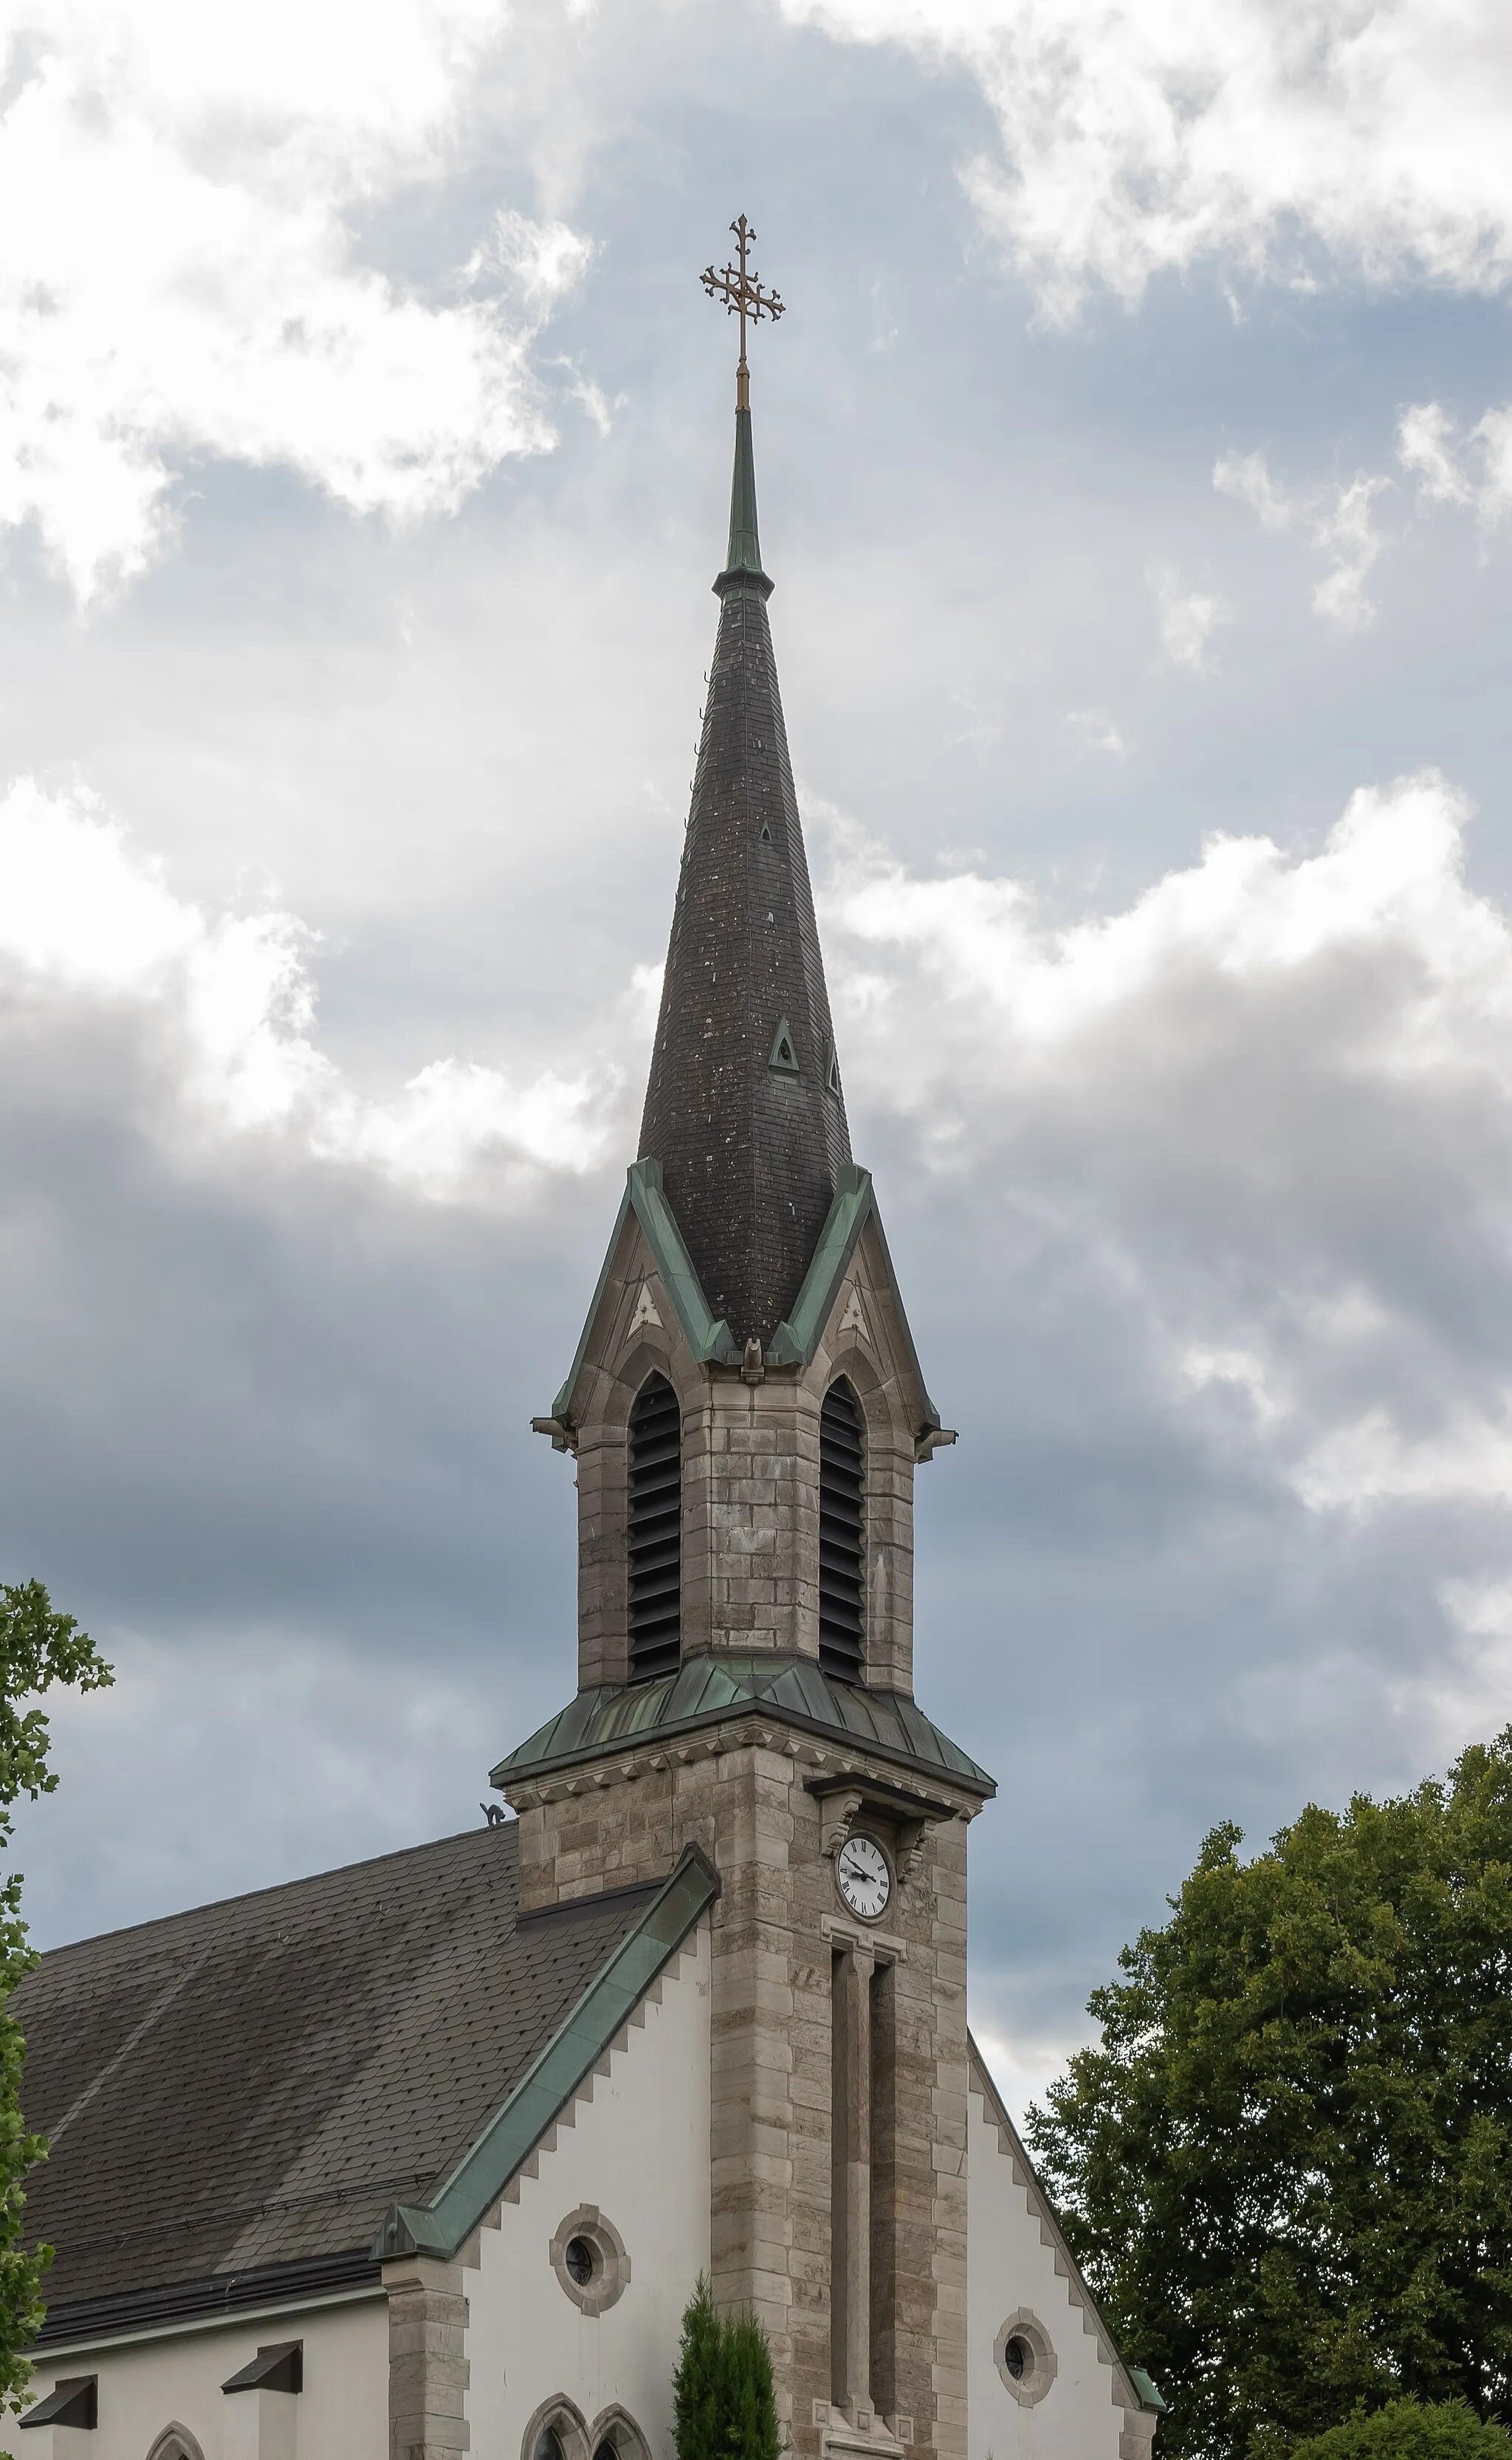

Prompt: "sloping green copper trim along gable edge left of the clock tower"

[374,1845,721,2263]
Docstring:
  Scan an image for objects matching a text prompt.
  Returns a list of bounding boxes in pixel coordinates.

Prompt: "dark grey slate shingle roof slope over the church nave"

[13,1828,656,2332]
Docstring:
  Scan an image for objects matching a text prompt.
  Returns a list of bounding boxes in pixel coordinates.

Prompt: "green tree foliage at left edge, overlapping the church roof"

[0,1579,111,2411]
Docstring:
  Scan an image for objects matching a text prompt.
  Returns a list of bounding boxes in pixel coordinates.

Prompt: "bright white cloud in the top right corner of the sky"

[784,0,1512,317]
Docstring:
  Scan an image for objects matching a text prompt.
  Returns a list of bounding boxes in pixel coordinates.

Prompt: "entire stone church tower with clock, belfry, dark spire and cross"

[494,219,993,2460]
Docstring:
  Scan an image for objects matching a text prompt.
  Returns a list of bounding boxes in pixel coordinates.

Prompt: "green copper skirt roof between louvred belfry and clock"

[489,1653,998,1796]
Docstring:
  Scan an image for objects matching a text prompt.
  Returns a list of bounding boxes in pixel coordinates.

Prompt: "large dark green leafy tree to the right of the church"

[1030,1727,1512,2460]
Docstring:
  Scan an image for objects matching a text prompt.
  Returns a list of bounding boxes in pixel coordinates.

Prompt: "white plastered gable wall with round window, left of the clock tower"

[464,1919,710,2460]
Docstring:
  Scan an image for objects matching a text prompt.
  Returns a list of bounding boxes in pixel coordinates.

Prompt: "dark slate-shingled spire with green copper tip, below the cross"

[639,386,850,1346]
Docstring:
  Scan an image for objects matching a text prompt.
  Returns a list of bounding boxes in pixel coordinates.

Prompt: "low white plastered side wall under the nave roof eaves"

[0,2290,388,2460]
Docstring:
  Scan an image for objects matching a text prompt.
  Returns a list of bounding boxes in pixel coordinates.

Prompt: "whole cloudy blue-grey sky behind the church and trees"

[0,0,1512,2103]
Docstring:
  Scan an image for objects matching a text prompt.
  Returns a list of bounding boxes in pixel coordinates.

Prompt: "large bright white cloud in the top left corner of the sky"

[0,0,588,602]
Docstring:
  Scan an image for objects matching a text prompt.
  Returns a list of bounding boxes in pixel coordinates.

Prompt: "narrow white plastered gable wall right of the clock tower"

[966,2076,1148,2460]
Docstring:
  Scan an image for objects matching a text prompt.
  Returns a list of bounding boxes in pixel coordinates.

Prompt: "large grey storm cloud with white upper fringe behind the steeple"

[14,752,1512,2115]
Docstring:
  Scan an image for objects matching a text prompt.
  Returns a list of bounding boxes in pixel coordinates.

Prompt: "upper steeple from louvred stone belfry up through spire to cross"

[526,216,963,1702]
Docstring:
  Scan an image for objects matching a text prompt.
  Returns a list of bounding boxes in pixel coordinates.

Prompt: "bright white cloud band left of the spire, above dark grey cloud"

[0,780,617,1195]
